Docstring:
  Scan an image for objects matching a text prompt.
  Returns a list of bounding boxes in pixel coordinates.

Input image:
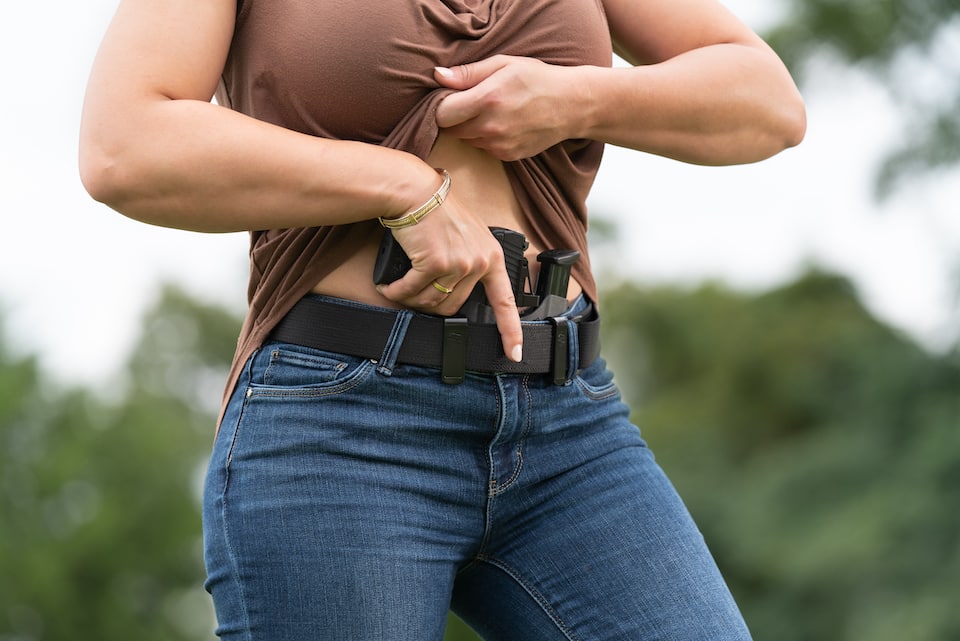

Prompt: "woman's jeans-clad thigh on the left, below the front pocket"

[204,345,495,641]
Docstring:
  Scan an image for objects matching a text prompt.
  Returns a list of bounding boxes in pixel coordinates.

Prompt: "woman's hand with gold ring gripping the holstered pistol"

[377,188,523,362]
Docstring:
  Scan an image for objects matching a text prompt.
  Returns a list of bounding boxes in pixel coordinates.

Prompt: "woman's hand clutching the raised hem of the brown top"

[434,55,577,161]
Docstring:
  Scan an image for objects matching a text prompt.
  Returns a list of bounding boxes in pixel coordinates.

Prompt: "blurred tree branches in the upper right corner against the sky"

[765,0,960,197]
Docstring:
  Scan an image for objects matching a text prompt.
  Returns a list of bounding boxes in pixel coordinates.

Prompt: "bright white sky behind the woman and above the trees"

[0,0,960,390]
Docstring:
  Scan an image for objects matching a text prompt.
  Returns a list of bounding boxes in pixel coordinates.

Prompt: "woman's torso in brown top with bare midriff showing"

[217,0,611,314]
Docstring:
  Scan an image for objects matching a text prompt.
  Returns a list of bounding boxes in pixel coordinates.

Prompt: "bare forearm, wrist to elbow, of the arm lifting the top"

[571,43,806,165]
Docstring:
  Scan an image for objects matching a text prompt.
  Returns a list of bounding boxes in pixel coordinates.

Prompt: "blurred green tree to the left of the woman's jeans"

[0,290,232,641]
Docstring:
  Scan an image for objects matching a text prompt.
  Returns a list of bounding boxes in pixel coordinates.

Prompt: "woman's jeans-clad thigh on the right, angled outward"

[454,362,750,641]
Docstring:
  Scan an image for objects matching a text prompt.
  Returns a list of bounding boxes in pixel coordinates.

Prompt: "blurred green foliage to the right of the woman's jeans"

[603,273,960,641]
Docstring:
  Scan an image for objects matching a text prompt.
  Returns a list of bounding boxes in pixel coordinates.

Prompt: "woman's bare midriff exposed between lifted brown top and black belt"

[313,133,580,307]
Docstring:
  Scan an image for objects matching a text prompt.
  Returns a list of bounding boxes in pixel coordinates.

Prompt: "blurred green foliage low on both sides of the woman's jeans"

[0,272,960,641]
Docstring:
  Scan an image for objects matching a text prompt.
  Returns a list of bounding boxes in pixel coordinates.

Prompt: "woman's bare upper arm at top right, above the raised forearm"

[603,0,766,64]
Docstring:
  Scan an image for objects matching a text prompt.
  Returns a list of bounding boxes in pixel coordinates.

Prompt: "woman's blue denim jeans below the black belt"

[203,296,750,641]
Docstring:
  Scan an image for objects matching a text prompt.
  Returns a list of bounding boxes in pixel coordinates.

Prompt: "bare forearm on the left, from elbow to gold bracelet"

[80,98,438,232]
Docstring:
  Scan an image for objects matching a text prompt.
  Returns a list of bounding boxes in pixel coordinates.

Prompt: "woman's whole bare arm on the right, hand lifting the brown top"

[434,0,806,165]
